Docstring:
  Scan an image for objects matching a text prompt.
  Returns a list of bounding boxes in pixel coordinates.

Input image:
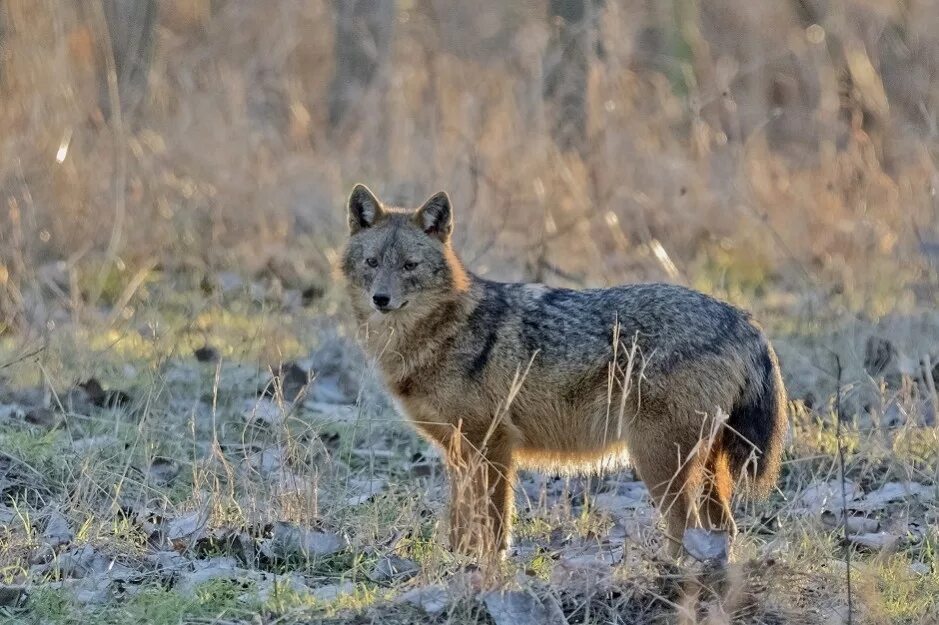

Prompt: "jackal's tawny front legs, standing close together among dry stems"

[447,432,515,558]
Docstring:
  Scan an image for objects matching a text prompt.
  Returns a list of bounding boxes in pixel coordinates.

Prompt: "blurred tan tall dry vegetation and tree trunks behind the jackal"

[0,0,939,342]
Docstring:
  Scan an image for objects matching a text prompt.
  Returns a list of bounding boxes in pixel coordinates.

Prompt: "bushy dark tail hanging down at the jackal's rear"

[722,342,789,497]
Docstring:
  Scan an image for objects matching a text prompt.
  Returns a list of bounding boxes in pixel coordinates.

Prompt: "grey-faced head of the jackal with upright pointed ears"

[342,185,467,316]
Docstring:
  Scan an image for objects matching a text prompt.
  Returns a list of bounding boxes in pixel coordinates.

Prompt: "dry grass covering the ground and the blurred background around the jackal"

[0,0,939,623]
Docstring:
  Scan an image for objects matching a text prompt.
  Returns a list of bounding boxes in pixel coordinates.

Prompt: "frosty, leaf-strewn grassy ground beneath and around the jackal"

[0,275,939,625]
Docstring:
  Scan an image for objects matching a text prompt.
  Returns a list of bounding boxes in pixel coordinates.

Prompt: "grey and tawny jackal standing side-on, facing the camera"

[342,185,787,555]
